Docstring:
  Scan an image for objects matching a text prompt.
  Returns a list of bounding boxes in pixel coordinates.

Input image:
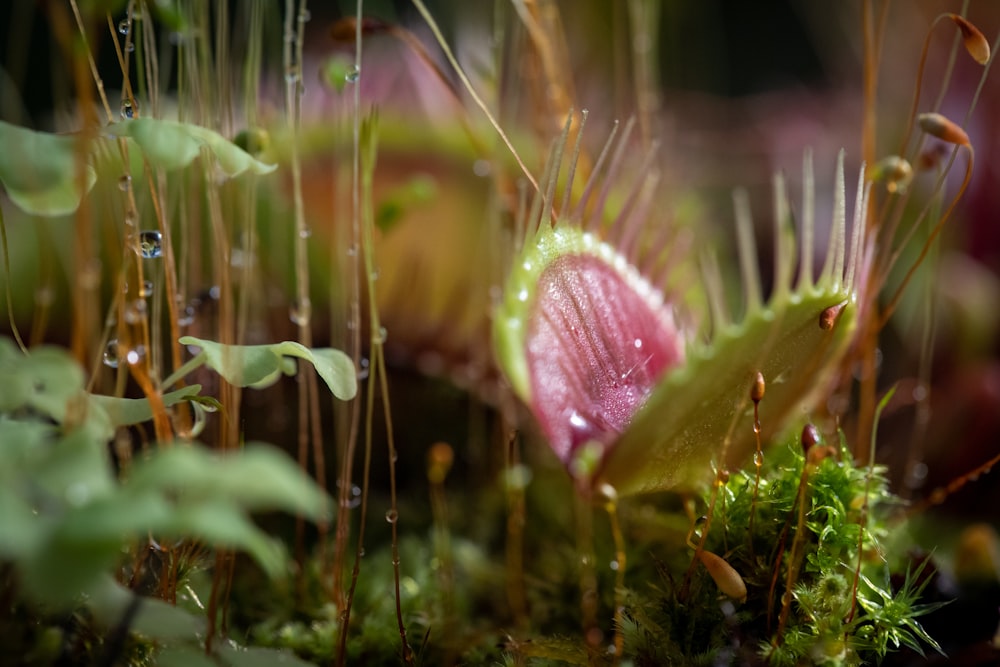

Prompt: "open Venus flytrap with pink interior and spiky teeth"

[494,140,869,494]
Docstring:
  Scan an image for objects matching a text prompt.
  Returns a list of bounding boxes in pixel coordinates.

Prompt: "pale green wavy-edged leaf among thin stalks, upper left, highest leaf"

[104,118,277,176]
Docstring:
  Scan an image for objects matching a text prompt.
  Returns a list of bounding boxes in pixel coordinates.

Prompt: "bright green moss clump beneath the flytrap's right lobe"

[600,430,940,665]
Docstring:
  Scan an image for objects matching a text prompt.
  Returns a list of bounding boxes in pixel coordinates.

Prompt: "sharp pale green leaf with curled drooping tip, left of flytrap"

[180,336,357,400]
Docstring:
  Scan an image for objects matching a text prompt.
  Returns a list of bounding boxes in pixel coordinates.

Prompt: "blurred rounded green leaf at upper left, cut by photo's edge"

[0,121,97,216]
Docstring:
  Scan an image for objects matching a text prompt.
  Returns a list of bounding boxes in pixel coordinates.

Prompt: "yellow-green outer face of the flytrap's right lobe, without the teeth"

[600,291,856,493]
